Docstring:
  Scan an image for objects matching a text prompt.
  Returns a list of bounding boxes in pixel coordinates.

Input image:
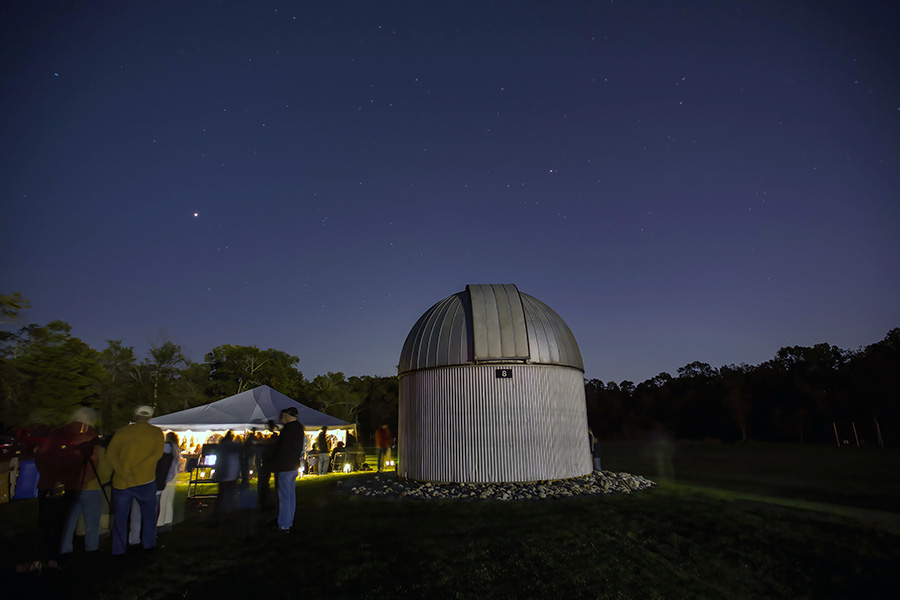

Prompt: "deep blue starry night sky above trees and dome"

[0,0,900,382]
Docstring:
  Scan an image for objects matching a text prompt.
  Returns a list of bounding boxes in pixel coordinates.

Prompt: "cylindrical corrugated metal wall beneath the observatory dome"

[398,364,593,482]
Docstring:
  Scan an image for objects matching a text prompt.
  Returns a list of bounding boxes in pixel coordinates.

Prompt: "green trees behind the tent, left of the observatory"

[0,294,398,442]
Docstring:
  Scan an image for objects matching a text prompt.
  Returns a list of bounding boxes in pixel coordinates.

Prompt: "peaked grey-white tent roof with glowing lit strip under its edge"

[150,385,356,448]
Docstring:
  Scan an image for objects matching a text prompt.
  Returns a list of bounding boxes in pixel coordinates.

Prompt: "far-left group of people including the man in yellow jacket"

[18,406,176,571]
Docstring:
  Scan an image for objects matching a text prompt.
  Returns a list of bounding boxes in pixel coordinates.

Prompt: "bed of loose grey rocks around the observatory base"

[338,471,656,502]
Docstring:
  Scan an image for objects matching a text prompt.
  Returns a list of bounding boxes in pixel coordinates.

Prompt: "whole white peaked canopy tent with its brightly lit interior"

[150,385,365,499]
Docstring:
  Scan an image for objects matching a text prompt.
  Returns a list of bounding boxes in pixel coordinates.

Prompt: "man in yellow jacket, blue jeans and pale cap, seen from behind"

[106,406,164,556]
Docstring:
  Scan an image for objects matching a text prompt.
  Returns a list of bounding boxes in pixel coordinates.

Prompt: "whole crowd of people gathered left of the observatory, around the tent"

[18,406,393,572]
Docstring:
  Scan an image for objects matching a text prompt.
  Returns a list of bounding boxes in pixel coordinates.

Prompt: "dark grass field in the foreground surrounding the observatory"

[0,444,900,598]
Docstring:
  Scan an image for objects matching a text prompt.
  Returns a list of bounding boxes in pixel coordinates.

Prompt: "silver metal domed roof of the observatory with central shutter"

[400,284,584,374]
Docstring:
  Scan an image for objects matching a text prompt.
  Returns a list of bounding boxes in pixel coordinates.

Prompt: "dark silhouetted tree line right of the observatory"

[585,328,900,445]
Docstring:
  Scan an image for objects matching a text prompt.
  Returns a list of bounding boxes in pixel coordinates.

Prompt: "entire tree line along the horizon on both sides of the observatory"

[0,294,900,444]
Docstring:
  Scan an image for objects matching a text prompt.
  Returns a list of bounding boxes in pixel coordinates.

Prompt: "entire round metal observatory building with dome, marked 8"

[397,284,592,482]
